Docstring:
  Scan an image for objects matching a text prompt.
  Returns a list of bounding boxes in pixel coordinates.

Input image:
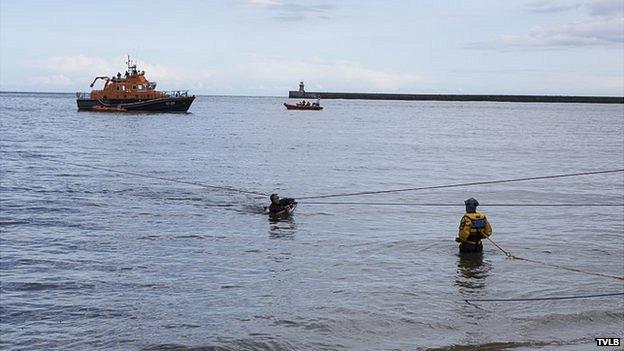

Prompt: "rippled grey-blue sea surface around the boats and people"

[0,93,624,351]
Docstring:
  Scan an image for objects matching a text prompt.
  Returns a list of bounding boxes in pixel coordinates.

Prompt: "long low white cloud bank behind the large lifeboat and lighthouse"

[28,55,423,95]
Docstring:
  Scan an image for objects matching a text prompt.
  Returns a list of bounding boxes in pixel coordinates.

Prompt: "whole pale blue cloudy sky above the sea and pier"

[0,0,624,96]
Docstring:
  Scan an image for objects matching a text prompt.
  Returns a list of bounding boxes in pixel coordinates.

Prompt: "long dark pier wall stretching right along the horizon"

[288,90,624,104]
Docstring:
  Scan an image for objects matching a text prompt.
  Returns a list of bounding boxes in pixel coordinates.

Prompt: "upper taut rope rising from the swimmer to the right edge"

[298,168,624,200]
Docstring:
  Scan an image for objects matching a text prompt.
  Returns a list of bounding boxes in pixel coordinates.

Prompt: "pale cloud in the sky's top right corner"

[466,0,624,51]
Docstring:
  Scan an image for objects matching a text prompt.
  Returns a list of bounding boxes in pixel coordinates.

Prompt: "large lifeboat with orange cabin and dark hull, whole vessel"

[76,57,195,112]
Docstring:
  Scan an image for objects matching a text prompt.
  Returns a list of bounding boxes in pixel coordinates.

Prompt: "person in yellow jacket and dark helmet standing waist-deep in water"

[455,198,492,252]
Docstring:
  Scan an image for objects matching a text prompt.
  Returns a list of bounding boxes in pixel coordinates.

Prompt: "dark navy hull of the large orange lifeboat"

[76,96,195,112]
